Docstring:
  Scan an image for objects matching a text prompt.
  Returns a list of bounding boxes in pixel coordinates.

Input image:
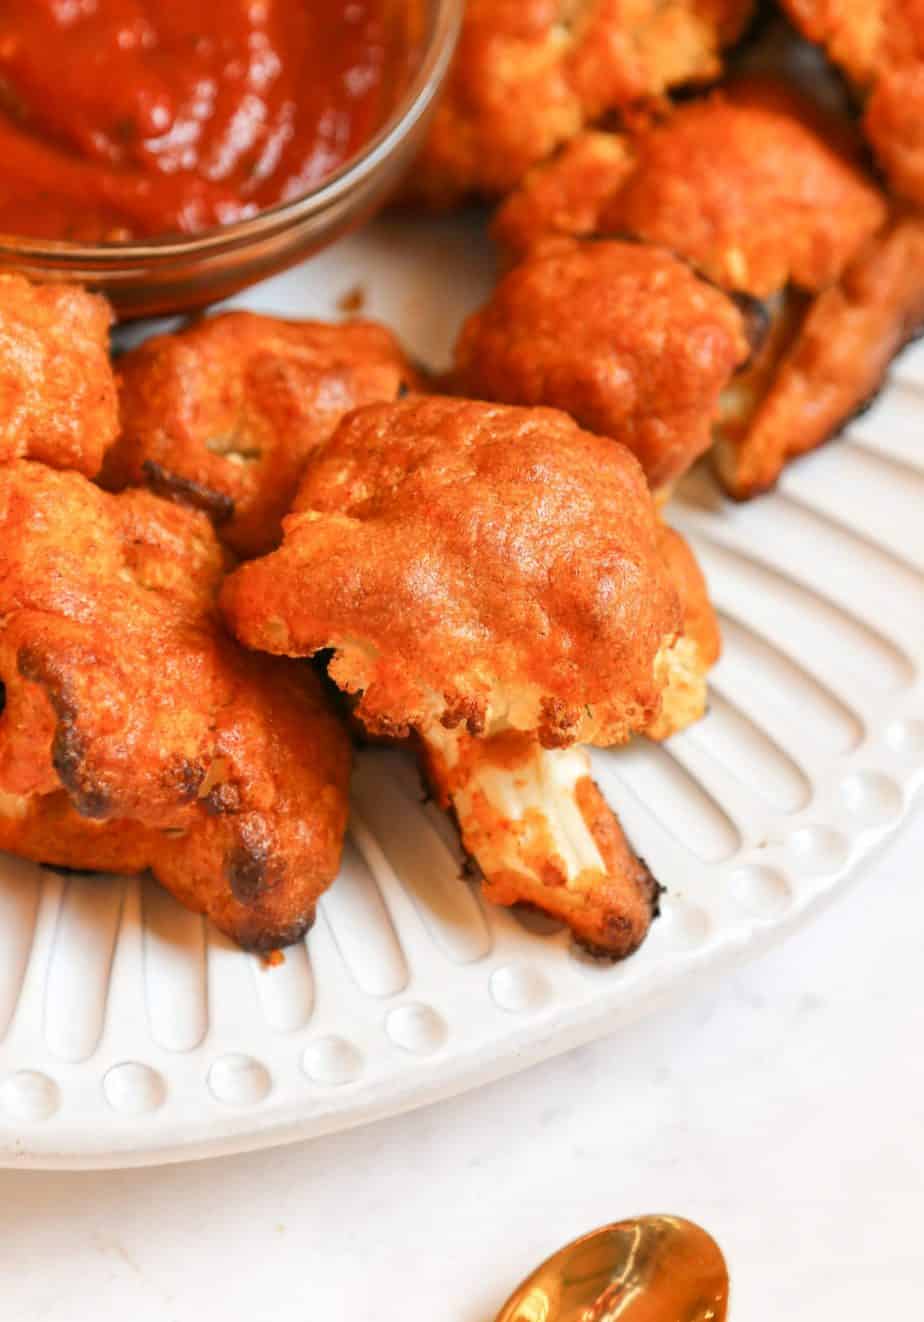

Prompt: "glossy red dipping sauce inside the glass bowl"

[0,0,403,242]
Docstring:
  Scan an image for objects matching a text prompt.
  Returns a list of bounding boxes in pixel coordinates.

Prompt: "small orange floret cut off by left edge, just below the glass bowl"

[0,275,119,477]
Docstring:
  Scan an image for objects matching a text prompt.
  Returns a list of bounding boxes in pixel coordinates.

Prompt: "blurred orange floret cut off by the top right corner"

[784,0,924,205]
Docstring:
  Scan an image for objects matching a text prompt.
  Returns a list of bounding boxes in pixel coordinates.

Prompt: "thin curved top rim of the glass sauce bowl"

[0,0,464,266]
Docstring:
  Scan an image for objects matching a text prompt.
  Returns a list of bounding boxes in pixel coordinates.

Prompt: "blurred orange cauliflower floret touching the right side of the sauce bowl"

[406,0,753,206]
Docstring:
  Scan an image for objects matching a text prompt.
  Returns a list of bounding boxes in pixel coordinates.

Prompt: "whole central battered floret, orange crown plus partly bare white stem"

[222,398,683,954]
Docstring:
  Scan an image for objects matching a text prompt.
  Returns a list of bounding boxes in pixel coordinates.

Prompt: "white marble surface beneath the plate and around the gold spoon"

[0,805,924,1322]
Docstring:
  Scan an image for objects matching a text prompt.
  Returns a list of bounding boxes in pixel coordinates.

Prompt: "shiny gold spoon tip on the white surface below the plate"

[496,1216,728,1322]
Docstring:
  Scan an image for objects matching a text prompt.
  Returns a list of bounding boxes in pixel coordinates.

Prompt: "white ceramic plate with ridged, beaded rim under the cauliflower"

[0,218,924,1167]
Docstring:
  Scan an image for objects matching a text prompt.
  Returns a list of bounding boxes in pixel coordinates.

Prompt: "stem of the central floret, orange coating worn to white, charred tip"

[422,730,661,960]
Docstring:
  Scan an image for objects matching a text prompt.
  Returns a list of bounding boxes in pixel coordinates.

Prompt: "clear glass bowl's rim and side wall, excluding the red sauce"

[0,0,464,320]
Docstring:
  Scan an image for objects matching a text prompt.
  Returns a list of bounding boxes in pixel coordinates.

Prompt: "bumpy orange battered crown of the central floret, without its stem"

[222,398,682,747]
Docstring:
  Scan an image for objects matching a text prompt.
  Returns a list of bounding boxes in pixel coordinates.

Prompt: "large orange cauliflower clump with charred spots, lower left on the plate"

[0,461,349,949]
